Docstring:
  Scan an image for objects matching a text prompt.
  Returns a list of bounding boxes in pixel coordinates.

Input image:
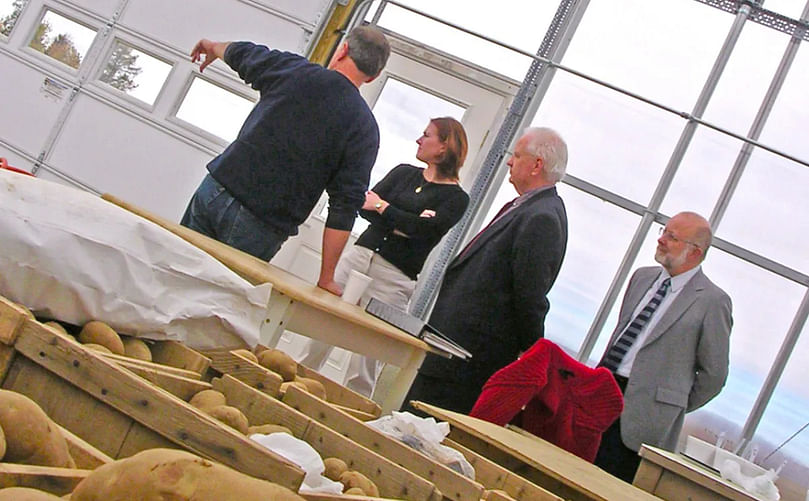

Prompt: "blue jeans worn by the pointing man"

[180,174,289,261]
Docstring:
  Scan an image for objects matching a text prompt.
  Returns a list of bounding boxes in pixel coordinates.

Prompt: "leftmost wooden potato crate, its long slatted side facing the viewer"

[0,298,304,491]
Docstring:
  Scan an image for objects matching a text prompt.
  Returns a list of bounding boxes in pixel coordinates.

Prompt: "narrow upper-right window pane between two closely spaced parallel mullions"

[704,22,789,136]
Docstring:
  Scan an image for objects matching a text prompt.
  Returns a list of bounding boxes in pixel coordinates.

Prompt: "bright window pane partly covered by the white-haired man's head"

[533,73,685,204]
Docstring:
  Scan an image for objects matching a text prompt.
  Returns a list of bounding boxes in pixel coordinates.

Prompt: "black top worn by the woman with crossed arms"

[356,164,469,280]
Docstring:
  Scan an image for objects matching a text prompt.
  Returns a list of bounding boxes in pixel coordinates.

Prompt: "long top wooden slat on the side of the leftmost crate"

[14,322,303,491]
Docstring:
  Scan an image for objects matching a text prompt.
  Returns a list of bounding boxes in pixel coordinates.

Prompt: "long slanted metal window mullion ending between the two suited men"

[577,1,750,362]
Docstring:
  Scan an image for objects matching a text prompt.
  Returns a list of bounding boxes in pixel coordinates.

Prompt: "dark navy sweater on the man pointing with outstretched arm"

[208,42,379,235]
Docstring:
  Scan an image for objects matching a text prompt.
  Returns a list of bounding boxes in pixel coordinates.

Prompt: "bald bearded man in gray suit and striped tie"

[595,212,733,482]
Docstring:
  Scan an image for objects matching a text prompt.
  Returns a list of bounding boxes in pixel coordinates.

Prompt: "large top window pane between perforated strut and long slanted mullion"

[562,0,733,110]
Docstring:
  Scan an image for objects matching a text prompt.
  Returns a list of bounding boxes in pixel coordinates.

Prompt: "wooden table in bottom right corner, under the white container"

[633,445,758,501]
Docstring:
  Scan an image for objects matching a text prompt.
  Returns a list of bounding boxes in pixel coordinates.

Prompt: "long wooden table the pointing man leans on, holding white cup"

[102,194,448,413]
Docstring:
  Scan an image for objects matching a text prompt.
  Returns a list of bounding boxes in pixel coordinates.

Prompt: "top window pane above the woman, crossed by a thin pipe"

[368,0,558,80]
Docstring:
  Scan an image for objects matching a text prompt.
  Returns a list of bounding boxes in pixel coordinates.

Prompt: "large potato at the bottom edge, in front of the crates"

[71,449,304,501]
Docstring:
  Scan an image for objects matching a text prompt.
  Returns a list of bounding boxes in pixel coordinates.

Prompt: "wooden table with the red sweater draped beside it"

[415,402,659,501]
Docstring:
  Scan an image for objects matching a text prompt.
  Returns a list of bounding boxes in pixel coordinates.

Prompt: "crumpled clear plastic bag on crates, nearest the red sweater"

[365,412,475,480]
